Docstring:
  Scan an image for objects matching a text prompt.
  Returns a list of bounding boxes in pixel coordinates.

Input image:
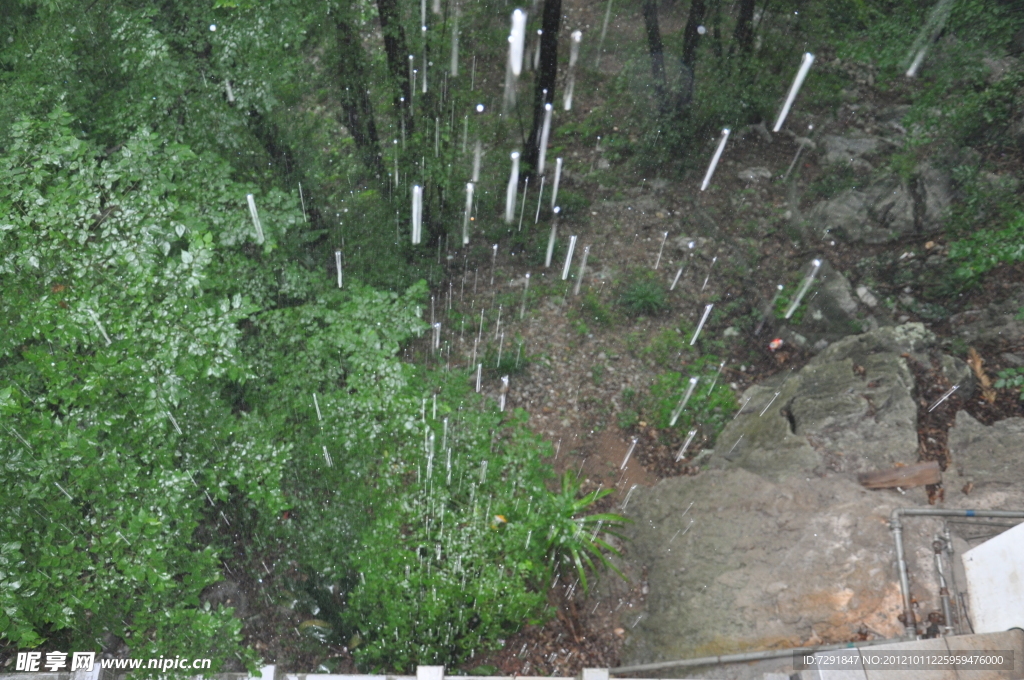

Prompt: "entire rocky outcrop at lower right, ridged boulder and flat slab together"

[599,324,1024,665]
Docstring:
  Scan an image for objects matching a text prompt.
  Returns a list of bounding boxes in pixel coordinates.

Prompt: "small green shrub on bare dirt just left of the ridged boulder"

[644,354,736,441]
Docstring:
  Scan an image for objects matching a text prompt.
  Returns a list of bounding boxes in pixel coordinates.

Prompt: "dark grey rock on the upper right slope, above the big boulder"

[808,165,952,244]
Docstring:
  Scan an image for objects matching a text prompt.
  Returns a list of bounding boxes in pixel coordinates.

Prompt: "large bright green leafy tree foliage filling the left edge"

[0,111,296,670]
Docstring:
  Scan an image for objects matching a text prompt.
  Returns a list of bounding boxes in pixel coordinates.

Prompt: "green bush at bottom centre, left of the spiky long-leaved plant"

[336,410,553,670]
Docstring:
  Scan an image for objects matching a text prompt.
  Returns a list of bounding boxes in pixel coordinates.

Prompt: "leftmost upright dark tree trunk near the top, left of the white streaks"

[335,14,385,179]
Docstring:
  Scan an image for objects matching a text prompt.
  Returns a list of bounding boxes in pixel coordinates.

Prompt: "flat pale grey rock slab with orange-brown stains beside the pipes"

[624,470,937,664]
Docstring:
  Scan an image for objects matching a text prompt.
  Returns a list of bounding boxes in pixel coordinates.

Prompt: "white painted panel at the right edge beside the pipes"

[963,523,1024,633]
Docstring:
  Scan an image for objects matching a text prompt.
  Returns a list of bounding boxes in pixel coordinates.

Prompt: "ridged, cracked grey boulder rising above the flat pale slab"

[716,324,937,479]
